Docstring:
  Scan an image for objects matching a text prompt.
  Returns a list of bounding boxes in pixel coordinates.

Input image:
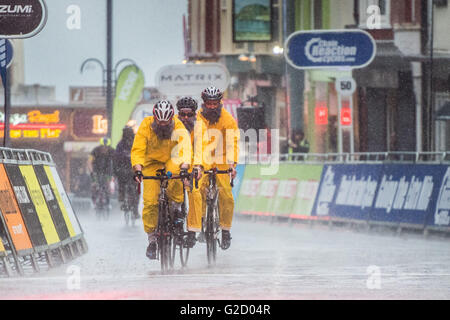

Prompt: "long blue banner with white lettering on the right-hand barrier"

[312,164,450,227]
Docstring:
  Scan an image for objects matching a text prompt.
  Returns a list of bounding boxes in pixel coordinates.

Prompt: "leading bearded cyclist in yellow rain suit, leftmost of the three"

[131,100,192,259]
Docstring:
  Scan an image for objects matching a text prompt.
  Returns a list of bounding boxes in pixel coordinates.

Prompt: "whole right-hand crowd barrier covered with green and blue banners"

[236,156,450,234]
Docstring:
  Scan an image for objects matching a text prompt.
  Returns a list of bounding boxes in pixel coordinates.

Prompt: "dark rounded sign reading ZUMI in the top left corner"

[0,0,47,39]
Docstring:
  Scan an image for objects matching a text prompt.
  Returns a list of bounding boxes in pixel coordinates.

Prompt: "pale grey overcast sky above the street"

[24,0,187,102]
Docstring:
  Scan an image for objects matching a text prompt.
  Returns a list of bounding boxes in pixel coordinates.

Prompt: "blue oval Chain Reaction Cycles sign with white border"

[284,29,376,69]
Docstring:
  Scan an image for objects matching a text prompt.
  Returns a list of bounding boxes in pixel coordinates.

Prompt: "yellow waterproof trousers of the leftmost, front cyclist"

[142,160,184,233]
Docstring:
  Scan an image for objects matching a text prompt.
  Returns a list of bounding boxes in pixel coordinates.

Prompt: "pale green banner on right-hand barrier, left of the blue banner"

[236,164,323,219]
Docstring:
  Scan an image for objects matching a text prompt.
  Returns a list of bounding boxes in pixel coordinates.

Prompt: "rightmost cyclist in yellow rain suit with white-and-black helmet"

[200,86,240,250]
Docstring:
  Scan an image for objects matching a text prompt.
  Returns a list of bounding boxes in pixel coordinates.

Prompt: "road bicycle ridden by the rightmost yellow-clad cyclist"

[194,168,234,266]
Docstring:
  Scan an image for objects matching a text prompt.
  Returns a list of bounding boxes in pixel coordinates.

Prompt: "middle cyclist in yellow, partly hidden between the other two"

[176,97,209,248]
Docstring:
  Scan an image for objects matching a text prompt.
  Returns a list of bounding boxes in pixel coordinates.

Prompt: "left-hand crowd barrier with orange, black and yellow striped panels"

[0,148,87,276]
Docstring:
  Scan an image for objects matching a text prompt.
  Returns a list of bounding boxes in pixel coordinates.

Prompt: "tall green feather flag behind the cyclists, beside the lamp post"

[111,65,144,147]
